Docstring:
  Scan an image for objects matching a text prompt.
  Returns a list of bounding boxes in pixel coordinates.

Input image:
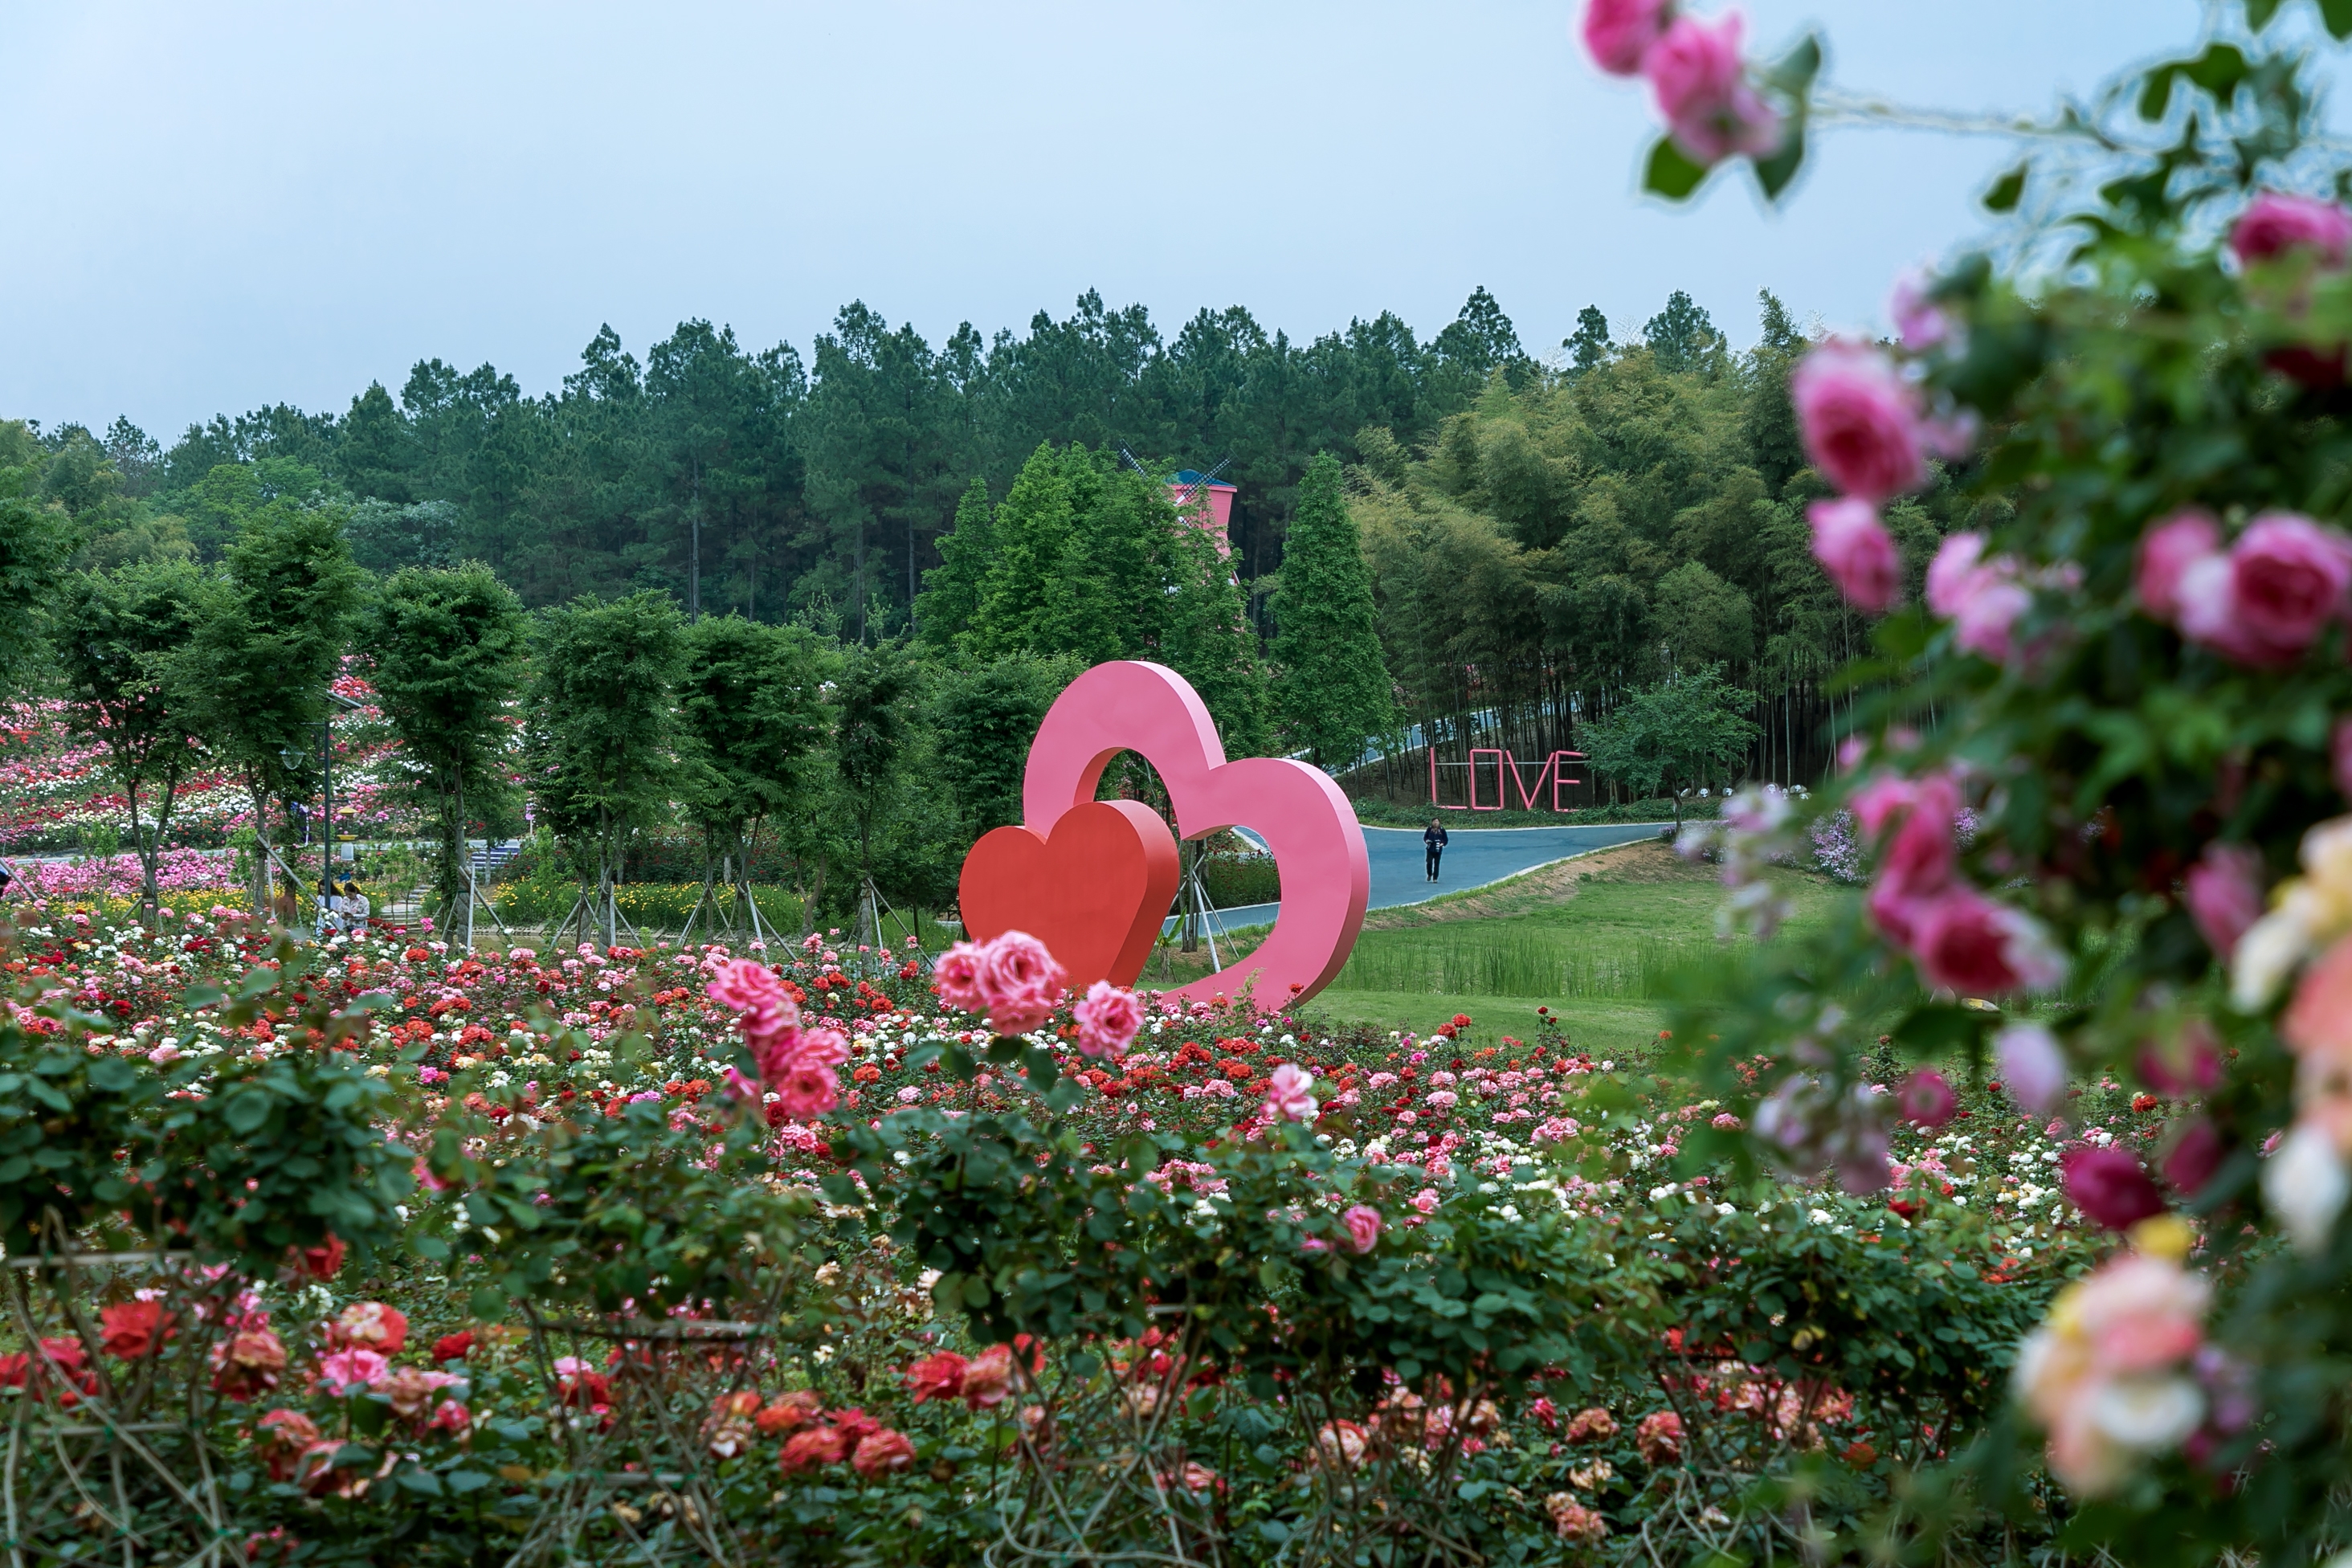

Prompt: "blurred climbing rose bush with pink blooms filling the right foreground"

[1599,0,2352,1563]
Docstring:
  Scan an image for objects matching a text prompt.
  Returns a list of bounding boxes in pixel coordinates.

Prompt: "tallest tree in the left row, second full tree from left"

[174,496,365,919]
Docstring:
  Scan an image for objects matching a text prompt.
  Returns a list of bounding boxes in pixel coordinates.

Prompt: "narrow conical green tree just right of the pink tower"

[1270,454,1394,769]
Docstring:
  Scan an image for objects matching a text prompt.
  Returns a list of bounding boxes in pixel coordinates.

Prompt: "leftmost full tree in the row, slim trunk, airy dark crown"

[51,561,205,926]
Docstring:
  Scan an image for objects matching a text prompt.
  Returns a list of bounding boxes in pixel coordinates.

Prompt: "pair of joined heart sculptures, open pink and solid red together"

[960,660,1371,1008]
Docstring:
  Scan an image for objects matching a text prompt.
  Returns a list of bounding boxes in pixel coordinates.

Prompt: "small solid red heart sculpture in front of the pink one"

[958,799,1178,992]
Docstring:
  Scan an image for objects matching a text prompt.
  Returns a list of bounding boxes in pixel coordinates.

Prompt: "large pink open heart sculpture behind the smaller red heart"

[1021,660,1371,1011]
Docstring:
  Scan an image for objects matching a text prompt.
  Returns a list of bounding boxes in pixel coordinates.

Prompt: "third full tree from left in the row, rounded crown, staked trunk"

[362,561,529,931]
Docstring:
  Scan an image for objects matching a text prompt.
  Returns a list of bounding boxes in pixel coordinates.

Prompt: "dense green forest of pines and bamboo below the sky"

[0,289,1985,823]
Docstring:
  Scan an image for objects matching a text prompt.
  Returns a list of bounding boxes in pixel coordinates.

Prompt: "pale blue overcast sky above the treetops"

[0,0,2239,442]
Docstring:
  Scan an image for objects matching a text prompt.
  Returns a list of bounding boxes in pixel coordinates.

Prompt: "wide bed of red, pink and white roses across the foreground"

[0,910,2162,1563]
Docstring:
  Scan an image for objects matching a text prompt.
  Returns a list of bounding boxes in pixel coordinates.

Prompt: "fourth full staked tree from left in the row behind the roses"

[525,590,687,945]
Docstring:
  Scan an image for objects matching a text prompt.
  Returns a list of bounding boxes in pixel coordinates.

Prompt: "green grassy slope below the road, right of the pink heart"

[1310,844,1832,1056]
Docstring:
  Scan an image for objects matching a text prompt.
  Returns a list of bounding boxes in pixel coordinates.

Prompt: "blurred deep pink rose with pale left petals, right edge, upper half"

[2173,512,2352,668]
